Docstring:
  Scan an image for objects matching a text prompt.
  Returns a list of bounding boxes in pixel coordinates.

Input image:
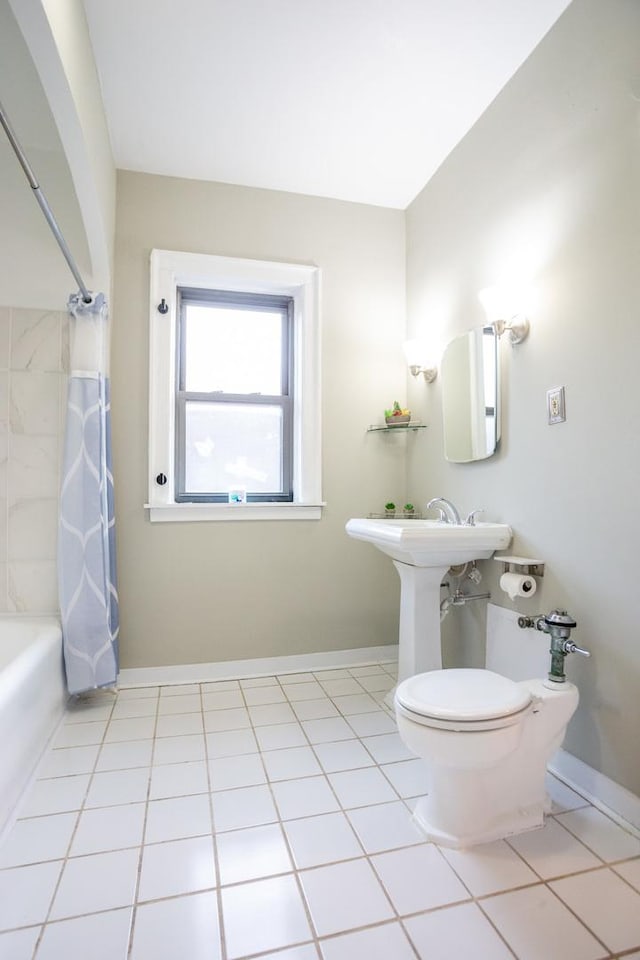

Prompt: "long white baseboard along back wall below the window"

[118,644,398,689]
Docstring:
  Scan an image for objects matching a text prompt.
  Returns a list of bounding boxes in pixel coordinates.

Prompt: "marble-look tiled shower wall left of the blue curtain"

[0,307,69,613]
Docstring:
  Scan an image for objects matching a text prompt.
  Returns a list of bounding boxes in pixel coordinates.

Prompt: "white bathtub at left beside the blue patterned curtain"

[0,616,67,837]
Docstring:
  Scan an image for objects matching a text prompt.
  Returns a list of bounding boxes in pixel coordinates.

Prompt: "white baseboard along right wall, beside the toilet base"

[549,750,640,836]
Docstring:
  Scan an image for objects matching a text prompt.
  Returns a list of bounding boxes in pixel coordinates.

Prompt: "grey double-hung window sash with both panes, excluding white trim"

[176,289,293,503]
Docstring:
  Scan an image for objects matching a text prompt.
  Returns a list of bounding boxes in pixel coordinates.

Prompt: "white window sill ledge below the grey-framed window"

[144,503,325,523]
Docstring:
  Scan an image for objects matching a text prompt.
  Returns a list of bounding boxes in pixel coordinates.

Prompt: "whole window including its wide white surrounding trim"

[147,250,322,521]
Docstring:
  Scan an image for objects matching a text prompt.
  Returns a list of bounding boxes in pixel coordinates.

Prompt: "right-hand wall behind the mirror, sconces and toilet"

[407,0,640,794]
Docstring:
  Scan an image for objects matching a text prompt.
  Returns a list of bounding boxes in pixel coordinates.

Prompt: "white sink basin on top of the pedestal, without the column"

[346,517,511,569]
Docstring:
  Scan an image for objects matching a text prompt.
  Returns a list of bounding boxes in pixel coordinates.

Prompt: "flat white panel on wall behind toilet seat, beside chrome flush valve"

[485,603,550,681]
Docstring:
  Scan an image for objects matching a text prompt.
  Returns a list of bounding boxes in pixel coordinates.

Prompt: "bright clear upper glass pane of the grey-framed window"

[184,303,283,396]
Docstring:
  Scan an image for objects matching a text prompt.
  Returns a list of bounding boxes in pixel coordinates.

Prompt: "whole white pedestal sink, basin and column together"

[346,517,511,681]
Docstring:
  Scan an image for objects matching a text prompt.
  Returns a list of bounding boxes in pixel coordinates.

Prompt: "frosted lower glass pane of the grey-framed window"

[185,402,283,493]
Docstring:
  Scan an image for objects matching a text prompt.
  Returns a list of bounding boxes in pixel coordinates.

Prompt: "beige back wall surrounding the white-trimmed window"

[112,172,412,667]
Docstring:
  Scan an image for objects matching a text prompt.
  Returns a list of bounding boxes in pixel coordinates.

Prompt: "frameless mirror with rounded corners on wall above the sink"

[440,327,500,463]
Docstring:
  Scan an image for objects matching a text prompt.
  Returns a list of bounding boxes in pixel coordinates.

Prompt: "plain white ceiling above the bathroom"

[84,0,569,209]
